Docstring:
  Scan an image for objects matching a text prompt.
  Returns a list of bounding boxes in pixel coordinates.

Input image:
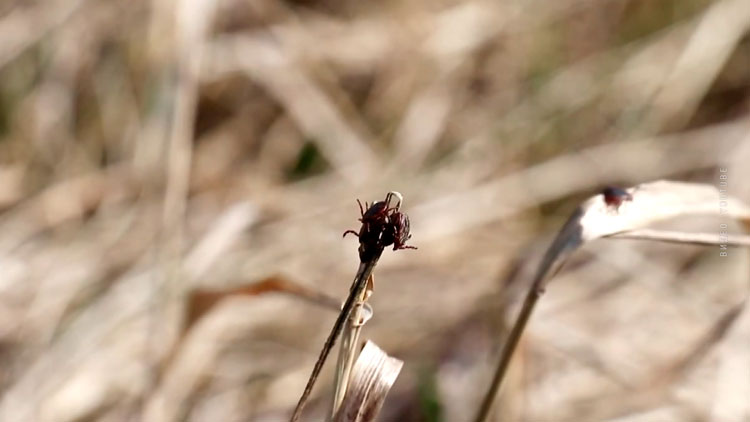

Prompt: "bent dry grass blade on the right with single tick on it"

[474,180,750,422]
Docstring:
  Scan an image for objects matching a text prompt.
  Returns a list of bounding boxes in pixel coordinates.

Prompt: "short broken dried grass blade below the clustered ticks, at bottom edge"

[334,341,404,422]
